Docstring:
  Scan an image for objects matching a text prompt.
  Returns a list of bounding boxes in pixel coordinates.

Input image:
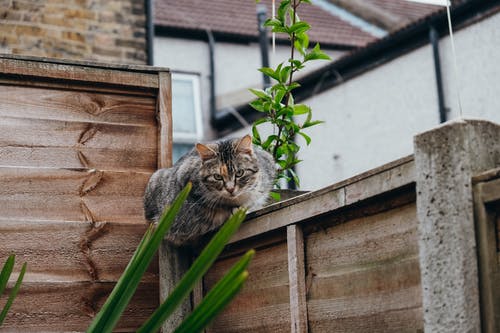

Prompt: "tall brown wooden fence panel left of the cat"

[0,55,171,332]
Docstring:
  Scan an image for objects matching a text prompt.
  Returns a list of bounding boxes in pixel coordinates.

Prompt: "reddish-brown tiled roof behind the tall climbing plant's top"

[154,0,375,49]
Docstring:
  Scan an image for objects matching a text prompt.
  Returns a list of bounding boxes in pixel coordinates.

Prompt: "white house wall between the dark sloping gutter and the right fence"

[298,14,500,189]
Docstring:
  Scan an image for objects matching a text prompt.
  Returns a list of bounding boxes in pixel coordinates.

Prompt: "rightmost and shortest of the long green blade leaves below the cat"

[174,250,255,333]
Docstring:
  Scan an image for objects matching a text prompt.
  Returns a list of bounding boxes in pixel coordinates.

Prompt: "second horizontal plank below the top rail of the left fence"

[0,117,157,172]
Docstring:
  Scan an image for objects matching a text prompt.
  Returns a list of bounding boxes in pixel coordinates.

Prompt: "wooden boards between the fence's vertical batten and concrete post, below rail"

[306,204,423,332]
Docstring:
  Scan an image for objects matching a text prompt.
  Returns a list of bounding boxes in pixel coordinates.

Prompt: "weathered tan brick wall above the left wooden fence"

[0,0,147,64]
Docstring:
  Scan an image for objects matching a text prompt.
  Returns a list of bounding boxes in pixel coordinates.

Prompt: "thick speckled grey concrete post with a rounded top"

[414,120,500,333]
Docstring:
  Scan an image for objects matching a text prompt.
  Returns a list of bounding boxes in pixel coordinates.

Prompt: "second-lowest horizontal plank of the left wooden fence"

[0,220,158,282]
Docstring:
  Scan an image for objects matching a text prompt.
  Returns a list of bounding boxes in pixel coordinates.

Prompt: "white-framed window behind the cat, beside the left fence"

[172,73,203,162]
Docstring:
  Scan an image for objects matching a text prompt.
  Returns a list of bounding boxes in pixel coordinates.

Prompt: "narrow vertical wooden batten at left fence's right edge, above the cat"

[157,72,172,168]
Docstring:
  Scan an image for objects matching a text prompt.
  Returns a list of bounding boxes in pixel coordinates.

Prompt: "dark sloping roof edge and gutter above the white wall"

[217,0,500,133]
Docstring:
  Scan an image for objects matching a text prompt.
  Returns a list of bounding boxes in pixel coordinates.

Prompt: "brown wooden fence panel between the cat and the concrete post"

[204,157,423,332]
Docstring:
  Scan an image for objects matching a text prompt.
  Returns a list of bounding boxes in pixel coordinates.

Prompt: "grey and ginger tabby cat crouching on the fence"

[144,135,276,246]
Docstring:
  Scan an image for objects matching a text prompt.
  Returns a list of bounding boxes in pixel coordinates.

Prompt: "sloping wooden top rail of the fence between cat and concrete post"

[229,156,415,243]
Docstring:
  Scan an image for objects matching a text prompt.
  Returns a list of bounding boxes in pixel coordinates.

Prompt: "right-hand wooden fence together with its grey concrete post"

[192,121,500,333]
